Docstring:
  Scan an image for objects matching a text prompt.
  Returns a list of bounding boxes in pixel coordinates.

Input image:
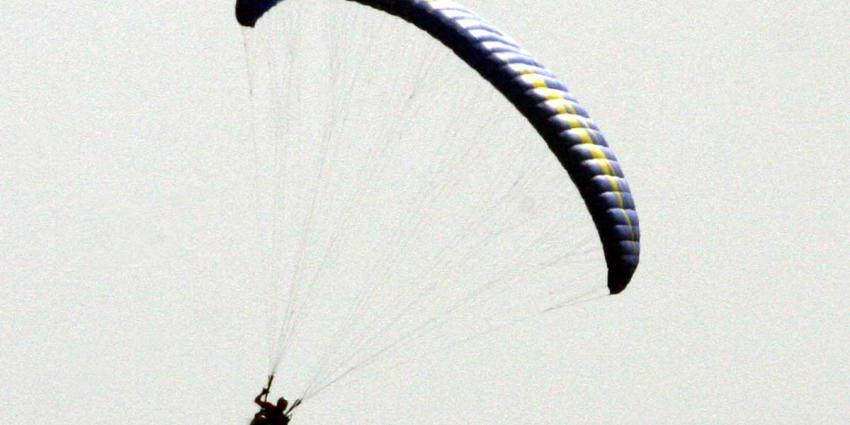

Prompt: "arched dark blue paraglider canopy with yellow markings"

[236,0,640,294]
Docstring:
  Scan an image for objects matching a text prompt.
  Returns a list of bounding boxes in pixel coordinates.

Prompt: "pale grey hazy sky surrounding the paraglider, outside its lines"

[0,0,850,424]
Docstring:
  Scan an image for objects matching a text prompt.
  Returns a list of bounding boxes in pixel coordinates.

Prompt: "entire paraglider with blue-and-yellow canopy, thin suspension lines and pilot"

[236,0,640,414]
